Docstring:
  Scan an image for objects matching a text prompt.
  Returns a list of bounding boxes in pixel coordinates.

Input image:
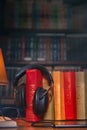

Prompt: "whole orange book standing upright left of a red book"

[52,70,65,120]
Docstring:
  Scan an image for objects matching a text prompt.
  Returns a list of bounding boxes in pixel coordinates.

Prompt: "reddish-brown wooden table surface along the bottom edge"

[0,119,87,130]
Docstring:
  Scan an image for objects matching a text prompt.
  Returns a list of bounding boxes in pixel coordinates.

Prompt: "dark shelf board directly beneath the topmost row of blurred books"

[0,28,81,36]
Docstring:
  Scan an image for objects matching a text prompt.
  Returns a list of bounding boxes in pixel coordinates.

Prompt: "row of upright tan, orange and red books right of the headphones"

[44,70,87,123]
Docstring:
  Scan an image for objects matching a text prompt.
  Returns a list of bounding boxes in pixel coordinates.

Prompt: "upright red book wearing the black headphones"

[26,69,43,122]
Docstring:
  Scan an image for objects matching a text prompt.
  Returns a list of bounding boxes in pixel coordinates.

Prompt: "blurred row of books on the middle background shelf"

[0,35,87,63]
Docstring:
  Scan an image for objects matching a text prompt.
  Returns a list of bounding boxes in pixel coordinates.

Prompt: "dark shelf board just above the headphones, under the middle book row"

[6,61,87,67]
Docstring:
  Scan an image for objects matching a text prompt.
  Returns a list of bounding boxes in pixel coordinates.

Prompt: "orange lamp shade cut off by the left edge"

[0,48,8,85]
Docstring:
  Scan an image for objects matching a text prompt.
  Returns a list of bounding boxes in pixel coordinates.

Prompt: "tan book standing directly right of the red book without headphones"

[75,71,86,119]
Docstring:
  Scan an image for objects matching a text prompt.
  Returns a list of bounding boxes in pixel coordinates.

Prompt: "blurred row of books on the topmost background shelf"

[4,0,72,29]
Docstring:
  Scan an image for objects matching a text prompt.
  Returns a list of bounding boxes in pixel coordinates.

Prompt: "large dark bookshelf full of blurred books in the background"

[0,0,87,107]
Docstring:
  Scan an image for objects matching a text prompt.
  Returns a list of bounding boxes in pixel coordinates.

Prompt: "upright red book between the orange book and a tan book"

[64,71,77,120]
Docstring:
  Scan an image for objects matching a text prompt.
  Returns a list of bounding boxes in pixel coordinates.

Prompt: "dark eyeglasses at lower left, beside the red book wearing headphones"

[0,107,21,118]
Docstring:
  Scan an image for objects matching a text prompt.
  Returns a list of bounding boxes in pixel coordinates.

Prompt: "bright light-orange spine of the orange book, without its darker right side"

[53,70,61,120]
